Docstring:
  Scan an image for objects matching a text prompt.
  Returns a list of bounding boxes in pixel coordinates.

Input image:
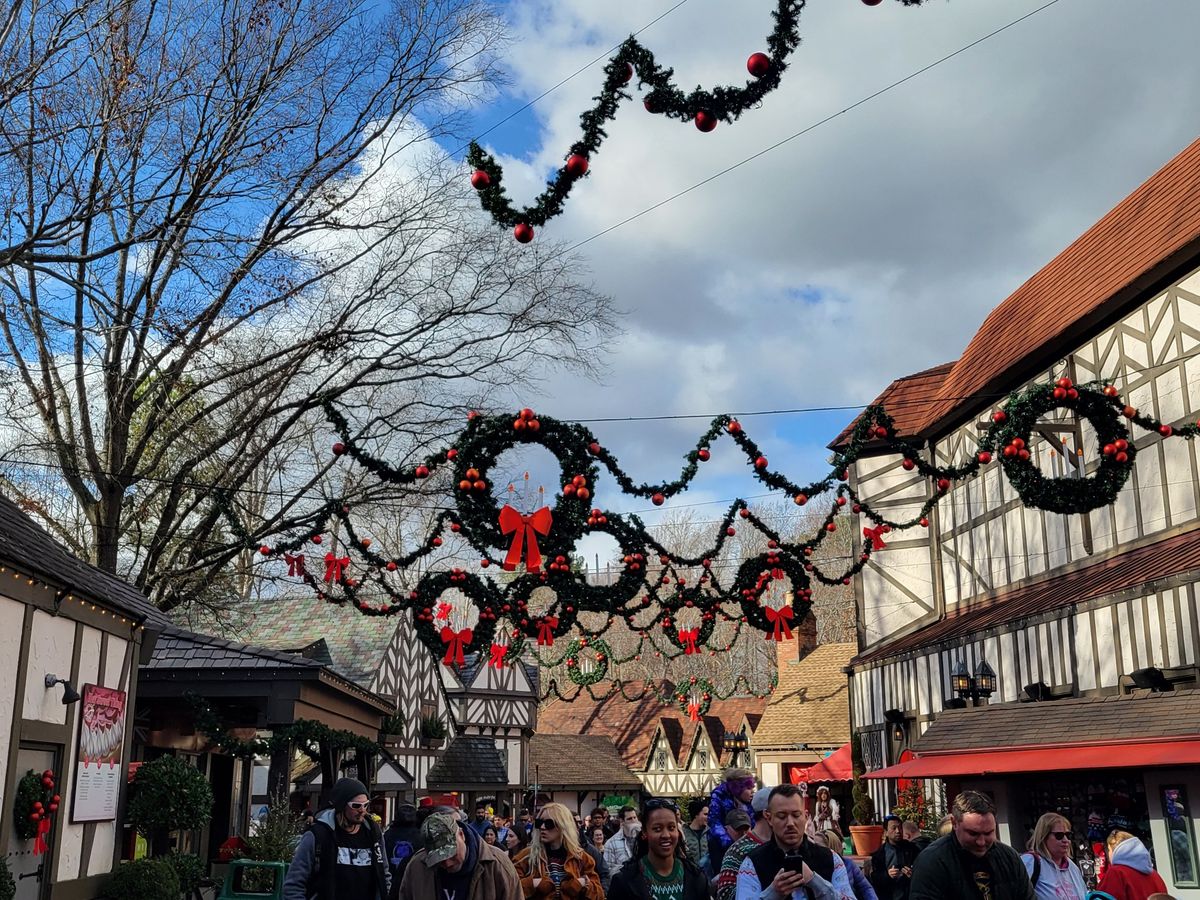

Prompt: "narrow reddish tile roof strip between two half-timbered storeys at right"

[852,528,1200,665]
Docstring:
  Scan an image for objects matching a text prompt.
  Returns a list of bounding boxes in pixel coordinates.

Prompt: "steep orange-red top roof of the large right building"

[913,140,1200,433]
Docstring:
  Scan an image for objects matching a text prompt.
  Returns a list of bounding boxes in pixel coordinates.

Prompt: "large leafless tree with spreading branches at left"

[0,0,612,608]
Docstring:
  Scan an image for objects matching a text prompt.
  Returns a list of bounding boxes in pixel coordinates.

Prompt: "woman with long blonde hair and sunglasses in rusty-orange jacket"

[512,803,604,900]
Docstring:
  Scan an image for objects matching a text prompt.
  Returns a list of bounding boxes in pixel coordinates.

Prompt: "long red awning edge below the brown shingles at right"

[866,740,1200,778]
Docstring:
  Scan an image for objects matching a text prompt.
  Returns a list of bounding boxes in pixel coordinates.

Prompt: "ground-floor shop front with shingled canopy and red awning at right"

[868,690,1200,900]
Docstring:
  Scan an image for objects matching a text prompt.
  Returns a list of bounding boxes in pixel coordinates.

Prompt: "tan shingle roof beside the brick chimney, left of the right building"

[754,643,858,750]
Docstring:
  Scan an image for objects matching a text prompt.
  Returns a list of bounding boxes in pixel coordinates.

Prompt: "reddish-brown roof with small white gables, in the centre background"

[538,682,767,772]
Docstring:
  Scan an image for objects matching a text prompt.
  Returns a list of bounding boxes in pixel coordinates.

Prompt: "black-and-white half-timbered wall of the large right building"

[851,264,1200,816]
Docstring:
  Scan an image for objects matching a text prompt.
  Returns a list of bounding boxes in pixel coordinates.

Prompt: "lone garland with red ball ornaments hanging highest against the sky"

[467,0,925,244]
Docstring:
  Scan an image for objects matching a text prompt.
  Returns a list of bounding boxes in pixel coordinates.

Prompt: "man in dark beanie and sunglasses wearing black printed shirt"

[283,778,391,900]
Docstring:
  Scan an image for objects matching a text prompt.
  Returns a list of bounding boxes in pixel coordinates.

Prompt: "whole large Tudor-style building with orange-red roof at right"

[834,132,1200,898]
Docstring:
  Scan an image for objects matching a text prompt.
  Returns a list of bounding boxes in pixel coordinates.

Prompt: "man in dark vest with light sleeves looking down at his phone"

[737,785,854,900]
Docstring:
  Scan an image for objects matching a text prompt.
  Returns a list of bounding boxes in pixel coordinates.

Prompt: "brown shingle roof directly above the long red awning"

[913,690,1200,754]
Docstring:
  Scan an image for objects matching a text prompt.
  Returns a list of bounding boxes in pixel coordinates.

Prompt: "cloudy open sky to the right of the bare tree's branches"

[436,0,1200,564]
